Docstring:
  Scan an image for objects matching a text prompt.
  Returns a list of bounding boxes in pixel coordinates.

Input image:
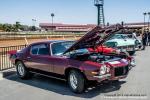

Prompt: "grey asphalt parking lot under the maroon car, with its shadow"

[0,47,150,100]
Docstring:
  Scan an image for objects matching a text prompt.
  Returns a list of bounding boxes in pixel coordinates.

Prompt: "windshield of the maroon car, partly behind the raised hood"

[51,41,75,56]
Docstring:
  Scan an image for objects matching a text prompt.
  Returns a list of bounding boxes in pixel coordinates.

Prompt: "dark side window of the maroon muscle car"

[31,44,49,55]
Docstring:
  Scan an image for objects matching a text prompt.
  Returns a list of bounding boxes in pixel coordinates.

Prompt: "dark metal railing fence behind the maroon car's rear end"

[0,45,26,71]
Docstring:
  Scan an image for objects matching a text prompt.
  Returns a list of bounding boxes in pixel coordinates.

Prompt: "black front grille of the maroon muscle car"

[114,66,129,76]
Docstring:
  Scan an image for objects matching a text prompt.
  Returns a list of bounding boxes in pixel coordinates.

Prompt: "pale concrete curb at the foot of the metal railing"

[0,68,16,80]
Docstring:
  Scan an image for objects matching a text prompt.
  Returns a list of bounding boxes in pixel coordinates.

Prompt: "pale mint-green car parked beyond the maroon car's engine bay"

[104,33,136,55]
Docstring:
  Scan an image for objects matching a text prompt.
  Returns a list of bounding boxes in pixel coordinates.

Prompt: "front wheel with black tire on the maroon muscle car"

[68,70,85,93]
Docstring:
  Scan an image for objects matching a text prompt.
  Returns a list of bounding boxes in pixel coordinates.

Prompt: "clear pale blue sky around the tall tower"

[0,0,150,25]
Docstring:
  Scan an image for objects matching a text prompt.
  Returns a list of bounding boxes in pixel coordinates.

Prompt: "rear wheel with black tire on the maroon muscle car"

[16,61,32,79]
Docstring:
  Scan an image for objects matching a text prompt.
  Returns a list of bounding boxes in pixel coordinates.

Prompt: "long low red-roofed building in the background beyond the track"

[39,22,148,33]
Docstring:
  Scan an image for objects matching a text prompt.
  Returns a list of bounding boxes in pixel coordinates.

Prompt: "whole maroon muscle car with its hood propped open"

[10,25,132,93]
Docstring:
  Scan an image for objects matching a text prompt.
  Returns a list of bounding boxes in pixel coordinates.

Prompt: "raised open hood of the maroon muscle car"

[64,24,123,54]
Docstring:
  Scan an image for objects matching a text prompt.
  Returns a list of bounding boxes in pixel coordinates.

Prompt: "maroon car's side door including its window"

[26,43,53,72]
